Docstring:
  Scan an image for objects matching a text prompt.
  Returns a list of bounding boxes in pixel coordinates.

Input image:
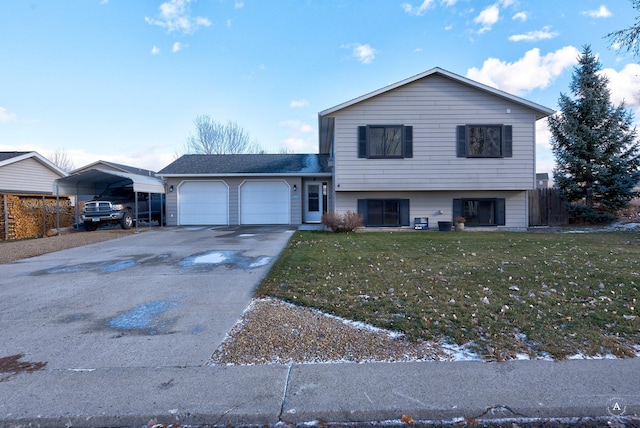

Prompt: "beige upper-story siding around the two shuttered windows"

[334,76,535,192]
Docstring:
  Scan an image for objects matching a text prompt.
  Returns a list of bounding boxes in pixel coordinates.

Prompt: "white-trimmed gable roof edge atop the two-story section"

[318,67,554,119]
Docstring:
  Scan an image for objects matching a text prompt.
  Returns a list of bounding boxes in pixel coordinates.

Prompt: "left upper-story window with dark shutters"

[358,125,413,159]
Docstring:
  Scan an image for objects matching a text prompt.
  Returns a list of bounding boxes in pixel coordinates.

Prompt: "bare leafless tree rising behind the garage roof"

[184,115,262,155]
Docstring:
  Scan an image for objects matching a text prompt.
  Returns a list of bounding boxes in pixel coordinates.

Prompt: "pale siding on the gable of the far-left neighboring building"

[0,158,62,194]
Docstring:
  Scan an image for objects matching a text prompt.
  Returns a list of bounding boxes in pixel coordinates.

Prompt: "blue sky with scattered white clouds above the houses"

[0,0,640,173]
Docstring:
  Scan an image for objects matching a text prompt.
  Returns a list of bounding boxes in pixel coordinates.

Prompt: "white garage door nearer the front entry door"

[240,181,289,224]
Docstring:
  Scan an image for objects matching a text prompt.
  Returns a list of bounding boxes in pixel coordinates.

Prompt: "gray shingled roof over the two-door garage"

[158,154,331,176]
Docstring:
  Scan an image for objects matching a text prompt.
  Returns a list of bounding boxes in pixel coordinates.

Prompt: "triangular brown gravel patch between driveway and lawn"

[209,298,451,365]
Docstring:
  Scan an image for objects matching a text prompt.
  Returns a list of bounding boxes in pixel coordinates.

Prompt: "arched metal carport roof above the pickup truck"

[54,169,165,195]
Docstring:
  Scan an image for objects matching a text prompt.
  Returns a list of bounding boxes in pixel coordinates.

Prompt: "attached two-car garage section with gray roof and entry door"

[158,154,331,226]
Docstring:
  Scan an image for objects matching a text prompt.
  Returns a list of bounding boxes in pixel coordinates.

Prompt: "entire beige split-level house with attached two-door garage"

[158,68,553,228]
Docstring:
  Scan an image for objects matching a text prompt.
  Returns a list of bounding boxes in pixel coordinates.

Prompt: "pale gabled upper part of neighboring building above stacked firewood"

[0,152,67,195]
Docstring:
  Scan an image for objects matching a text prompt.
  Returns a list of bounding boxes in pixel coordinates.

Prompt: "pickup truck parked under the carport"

[81,187,164,231]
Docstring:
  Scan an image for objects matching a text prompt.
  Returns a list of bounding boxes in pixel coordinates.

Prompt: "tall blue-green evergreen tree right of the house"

[549,46,640,222]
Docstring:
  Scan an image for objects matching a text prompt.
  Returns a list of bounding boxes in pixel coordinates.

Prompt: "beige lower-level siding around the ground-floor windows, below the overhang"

[335,191,529,229]
